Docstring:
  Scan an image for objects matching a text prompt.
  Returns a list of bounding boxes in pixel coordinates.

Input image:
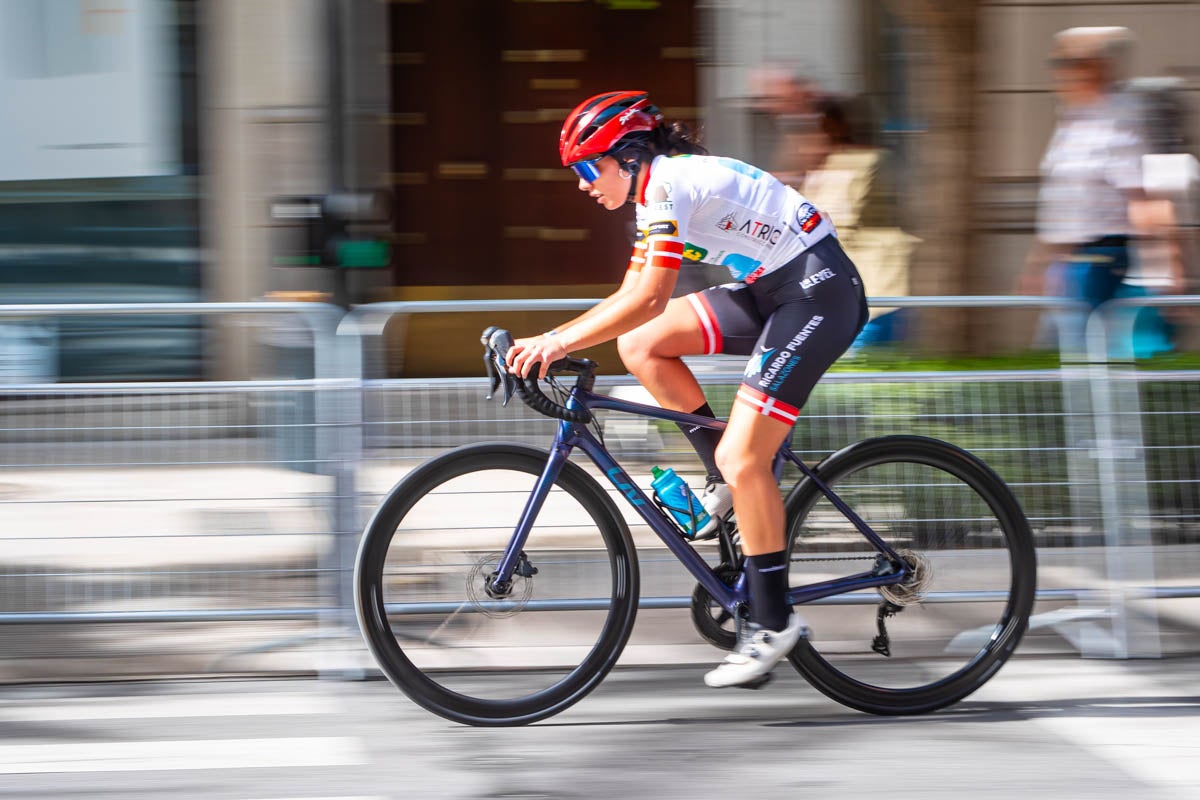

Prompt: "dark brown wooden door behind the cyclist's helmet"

[386,0,698,285]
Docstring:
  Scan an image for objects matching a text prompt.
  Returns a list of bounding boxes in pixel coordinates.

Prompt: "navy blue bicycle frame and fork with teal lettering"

[497,387,907,613]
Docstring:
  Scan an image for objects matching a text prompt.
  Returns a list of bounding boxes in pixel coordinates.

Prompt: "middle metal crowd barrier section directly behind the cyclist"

[340,297,1200,657]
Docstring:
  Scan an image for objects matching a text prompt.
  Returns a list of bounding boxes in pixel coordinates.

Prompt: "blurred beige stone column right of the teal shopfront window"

[200,0,330,379]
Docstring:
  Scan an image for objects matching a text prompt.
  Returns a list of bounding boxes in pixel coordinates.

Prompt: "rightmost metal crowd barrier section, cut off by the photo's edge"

[1086,295,1200,657]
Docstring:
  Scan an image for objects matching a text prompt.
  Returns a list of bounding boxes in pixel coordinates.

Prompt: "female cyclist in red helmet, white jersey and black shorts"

[509,91,866,686]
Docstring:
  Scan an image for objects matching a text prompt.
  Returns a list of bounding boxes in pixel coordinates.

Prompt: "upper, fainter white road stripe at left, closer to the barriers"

[0,692,343,722]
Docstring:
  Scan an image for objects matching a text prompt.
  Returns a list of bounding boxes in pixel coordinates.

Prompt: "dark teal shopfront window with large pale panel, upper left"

[0,0,205,380]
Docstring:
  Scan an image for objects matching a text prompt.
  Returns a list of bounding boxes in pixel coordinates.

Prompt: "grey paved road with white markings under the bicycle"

[0,657,1200,800]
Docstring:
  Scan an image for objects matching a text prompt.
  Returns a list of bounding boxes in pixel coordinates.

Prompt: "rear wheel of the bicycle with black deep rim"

[786,435,1037,715]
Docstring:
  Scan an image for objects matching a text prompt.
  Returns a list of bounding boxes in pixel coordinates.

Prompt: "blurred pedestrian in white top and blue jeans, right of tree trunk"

[1020,26,1182,354]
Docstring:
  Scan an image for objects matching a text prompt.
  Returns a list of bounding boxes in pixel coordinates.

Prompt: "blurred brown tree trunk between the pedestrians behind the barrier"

[883,0,980,351]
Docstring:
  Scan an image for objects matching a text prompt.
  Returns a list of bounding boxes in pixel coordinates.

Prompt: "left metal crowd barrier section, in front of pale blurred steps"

[0,302,356,680]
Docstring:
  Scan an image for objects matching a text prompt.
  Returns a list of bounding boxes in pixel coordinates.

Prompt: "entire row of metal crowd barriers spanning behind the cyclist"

[0,297,1200,680]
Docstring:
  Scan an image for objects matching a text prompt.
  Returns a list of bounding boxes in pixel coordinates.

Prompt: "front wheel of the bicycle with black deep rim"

[354,444,638,726]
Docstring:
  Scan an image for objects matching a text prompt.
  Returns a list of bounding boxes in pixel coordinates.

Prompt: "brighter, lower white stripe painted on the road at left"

[0,736,367,775]
